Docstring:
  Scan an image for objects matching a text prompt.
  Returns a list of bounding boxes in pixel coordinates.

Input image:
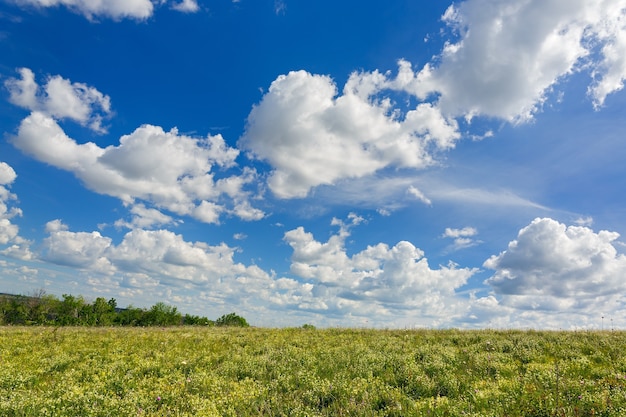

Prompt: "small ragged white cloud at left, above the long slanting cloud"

[4,68,111,133]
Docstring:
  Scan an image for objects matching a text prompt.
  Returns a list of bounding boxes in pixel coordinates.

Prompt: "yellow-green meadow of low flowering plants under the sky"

[0,326,626,417]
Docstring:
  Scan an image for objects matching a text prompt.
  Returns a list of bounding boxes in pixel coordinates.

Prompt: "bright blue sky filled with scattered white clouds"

[0,0,626,329]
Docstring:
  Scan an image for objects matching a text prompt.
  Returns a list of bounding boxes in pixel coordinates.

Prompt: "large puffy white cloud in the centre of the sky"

[239,71,459,198]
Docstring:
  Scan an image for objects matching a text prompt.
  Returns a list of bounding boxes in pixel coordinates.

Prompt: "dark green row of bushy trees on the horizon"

[0,291,249,327]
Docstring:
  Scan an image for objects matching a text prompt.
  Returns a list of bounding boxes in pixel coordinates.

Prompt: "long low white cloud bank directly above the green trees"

[33,220,310,320]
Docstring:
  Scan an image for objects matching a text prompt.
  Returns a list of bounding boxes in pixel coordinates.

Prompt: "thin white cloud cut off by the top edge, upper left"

[10,0,154,20]
